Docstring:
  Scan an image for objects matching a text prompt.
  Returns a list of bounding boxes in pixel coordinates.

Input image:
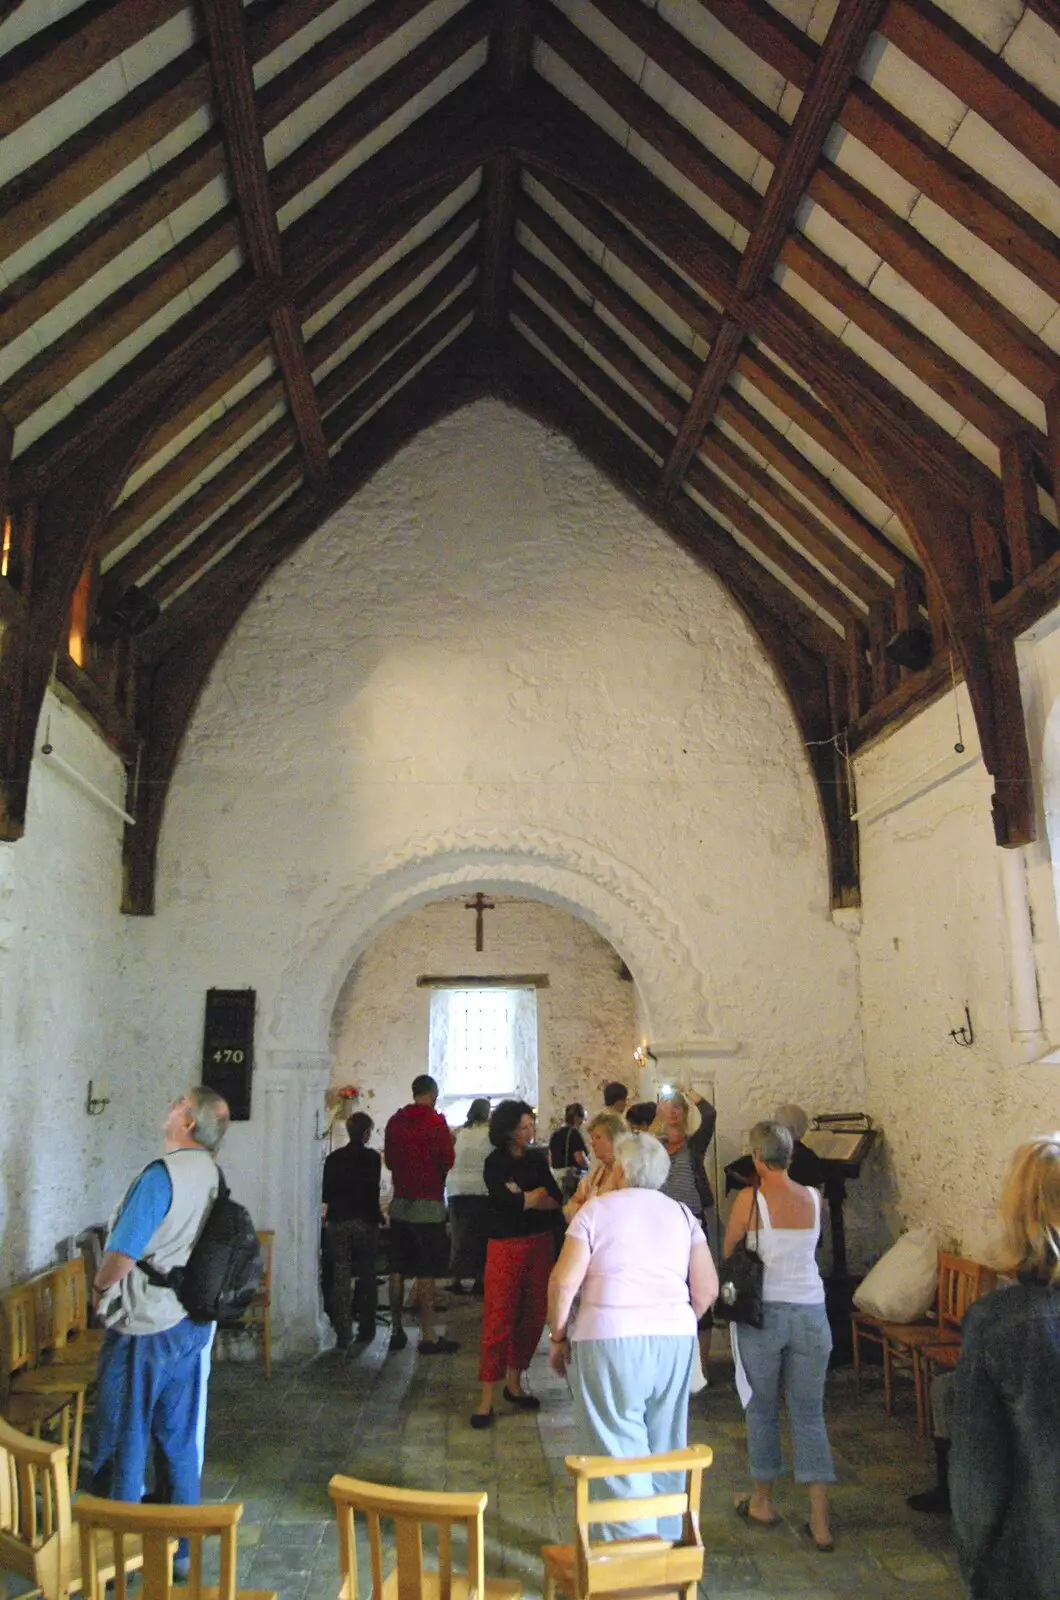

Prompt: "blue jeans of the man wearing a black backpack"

[91,1318,215,1506]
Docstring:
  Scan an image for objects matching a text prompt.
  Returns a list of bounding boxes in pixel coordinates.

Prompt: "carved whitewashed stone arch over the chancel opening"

[269,829,723,1056]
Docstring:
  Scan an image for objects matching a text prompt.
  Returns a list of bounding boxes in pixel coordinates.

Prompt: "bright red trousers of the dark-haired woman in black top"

[479,1230,556,1384]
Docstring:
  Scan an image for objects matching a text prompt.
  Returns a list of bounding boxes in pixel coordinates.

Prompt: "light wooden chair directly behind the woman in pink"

[541,1445,714,1600]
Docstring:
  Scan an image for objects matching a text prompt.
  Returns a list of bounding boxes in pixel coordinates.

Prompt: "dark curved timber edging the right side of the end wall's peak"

[504,339,860,907]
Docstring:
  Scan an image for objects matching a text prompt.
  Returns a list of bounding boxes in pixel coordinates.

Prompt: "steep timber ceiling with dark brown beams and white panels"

[0,0,1060,909]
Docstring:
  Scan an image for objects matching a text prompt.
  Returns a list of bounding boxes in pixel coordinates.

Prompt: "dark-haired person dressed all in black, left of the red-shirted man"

[322,1110,383,1350]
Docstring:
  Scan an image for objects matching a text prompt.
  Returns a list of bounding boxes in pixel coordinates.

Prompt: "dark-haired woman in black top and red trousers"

[471,1101,562,1427]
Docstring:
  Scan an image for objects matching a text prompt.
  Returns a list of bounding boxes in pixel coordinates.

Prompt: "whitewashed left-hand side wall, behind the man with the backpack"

[0,698,142,1283]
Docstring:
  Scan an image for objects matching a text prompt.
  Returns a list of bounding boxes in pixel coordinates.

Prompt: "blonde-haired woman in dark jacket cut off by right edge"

[950,1133,1060,1600]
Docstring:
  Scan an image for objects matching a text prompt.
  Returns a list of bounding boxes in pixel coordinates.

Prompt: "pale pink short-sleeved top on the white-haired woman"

[567,1189,706,1339]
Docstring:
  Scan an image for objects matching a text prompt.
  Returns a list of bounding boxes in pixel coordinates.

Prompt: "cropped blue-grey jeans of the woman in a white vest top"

[738,1301,836,1483]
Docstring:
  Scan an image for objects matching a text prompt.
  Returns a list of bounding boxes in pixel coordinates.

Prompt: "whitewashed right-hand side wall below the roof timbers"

[857,643,1060,1254]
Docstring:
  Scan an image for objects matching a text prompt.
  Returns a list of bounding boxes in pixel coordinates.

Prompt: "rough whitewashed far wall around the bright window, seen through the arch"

[331,896,640,1142]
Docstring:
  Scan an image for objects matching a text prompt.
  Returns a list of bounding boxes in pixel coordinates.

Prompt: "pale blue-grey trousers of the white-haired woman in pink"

[570,1333,695,1539]
